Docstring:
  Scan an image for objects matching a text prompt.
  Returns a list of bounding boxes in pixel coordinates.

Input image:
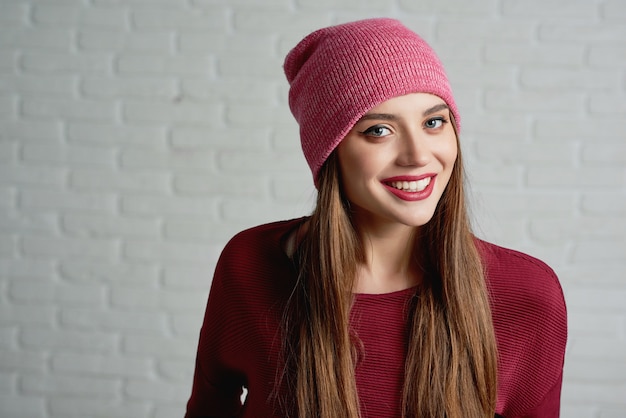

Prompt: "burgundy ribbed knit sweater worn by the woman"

[185,219,567,418]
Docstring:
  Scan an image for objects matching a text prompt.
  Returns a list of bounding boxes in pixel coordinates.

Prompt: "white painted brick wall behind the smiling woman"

[0,0,626,418]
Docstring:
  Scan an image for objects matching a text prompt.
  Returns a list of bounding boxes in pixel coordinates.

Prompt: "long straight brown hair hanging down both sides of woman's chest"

[283,122,497,418]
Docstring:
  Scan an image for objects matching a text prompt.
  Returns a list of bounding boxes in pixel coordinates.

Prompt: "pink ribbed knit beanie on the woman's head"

[284,18,460,184]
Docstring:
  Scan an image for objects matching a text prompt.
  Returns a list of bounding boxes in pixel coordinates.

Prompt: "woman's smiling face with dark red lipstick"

[337,93,457,227]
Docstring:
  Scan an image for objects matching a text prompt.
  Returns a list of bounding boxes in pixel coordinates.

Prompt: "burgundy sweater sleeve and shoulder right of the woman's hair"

[480,243,567,418]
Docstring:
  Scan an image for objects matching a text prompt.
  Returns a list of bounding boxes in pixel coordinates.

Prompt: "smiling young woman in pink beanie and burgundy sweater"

[186,19,567,418]
